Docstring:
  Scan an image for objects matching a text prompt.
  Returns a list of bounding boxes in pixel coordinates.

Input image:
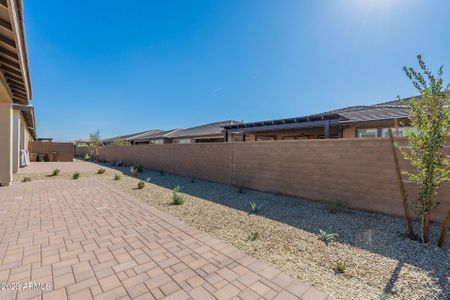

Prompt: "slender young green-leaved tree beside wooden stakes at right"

[402,55,450,243]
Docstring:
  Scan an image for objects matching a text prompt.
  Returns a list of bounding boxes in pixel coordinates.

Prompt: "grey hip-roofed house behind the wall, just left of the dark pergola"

[168,120,240,144]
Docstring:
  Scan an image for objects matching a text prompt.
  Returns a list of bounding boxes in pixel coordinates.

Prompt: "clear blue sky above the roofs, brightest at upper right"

[25,0,450,140]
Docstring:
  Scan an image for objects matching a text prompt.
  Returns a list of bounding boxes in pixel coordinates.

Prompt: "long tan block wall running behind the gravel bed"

[100,138,450,222]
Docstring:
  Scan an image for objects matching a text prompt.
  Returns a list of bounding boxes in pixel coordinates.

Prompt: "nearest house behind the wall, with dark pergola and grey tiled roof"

[224,100,409,141]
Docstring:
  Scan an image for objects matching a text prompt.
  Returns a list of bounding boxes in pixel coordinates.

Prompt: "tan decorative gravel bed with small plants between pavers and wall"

[16,166,450,299]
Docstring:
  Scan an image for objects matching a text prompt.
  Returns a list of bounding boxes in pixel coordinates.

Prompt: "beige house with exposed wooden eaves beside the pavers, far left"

[0,0,36,186]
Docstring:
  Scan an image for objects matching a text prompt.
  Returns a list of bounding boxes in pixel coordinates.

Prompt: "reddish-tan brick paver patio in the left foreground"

[0,179,327,300]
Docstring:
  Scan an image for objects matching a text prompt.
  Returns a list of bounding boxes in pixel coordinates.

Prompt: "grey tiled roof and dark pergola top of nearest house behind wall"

[225,98,409,129]
